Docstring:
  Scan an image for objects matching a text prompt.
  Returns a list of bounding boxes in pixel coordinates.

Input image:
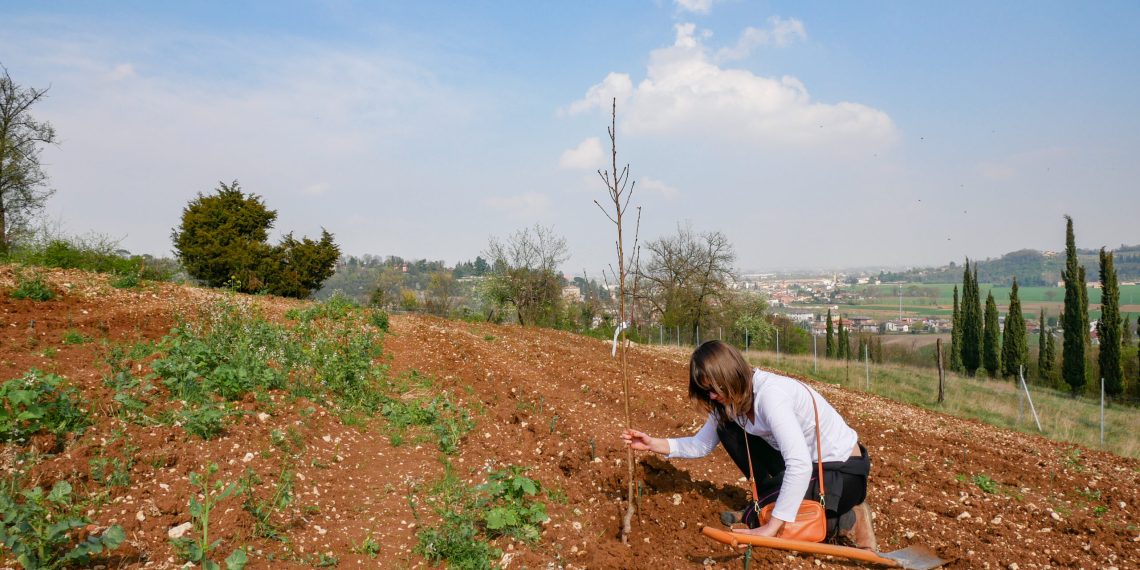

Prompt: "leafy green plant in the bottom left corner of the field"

[0,480,127,570]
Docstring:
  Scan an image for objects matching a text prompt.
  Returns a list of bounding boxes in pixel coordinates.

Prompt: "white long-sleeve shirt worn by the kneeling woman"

[667,369,858,522]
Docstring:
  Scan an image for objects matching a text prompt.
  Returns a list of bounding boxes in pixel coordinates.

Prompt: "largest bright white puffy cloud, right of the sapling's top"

[570,21,897,150]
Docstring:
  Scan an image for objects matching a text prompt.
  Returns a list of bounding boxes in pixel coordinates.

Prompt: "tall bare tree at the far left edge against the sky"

[0,66,56,254]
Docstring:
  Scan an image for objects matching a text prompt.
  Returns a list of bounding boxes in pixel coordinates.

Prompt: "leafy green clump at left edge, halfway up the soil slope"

[0,369,91,443]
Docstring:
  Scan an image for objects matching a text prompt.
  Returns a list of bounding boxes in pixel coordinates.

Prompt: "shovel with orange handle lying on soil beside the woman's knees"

[701,527,951,570]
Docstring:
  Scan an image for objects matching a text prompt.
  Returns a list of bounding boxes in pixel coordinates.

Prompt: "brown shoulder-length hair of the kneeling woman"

[689,341,752,423]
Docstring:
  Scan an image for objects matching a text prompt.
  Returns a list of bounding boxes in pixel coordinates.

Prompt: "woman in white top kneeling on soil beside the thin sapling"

[621,341,876,549]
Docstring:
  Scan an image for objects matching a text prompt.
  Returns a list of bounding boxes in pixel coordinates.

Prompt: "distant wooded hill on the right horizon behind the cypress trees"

[880,245,1140,286]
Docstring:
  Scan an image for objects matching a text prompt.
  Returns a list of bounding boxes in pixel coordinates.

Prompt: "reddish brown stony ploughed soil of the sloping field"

[0,267,1140,569]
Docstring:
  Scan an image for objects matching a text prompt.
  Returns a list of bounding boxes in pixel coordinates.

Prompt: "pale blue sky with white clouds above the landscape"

[0,0,1140,275]
